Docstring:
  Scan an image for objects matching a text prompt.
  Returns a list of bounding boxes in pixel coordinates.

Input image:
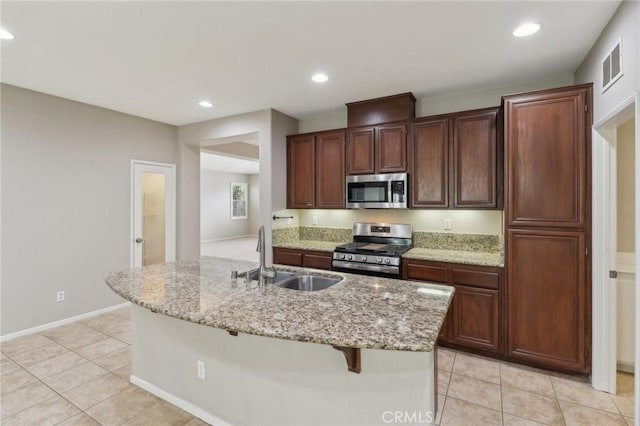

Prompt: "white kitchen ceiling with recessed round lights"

[1,0,619,125]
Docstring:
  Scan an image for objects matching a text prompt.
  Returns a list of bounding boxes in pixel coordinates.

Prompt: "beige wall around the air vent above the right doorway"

[576,1,640,123]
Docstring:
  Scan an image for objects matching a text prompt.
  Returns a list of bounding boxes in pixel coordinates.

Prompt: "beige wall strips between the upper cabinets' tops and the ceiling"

[299,73,573,133]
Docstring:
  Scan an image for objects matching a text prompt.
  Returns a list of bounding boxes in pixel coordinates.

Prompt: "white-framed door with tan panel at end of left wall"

[131,160,176,268]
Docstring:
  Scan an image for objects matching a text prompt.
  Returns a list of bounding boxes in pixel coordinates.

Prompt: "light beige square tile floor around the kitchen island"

[0,308,633,426]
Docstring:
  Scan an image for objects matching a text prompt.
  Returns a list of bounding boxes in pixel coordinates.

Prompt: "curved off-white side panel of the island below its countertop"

[131,305,436,425]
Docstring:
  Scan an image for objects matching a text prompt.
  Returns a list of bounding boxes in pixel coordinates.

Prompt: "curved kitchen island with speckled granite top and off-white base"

[106,257,453,424]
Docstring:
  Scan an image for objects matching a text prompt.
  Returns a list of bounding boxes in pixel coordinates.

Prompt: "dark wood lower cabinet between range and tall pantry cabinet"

[402,259,504,354]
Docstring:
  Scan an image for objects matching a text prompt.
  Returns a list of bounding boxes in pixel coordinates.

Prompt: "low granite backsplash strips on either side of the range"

[273,226,504,253]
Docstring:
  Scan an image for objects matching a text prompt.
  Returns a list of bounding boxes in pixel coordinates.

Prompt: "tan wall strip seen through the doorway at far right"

[616,120,636,253]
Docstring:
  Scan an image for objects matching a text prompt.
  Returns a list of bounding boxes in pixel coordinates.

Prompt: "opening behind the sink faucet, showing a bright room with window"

[200,136,260,261]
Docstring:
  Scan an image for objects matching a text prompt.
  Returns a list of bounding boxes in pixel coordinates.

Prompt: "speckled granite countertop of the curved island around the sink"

[105,256,453,352]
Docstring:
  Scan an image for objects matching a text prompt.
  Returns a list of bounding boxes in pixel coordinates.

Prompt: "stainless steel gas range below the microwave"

[332,222,413,278]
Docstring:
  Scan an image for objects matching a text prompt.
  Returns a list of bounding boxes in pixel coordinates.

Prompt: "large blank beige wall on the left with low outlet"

[0,84,177,335]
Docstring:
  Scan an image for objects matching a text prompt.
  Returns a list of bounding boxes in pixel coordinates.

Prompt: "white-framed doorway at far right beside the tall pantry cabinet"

[592,94,640,417]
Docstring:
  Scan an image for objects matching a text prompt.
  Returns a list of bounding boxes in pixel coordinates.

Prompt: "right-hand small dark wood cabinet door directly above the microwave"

[375,124,407,173]
